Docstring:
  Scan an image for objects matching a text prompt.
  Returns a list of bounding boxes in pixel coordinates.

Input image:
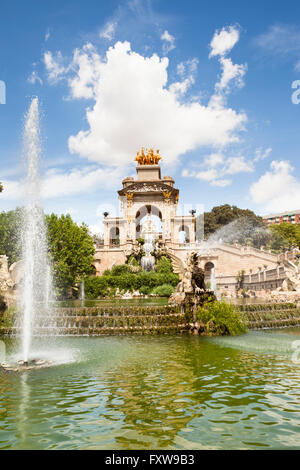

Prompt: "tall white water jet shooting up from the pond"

[19,98,52,362]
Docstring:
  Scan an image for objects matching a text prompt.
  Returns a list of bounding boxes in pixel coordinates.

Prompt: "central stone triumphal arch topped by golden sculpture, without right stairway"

[95,148,196,274]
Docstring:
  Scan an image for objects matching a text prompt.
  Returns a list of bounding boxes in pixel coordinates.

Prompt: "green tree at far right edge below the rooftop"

[269,222,300,251]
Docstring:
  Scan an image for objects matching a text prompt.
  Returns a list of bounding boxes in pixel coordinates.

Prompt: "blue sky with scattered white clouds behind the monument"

[0,0,300,231]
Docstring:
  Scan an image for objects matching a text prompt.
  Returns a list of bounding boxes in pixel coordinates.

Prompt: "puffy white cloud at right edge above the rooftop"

[250,160,300,212]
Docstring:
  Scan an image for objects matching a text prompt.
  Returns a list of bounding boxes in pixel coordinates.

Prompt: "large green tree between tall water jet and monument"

[46,214,95,297]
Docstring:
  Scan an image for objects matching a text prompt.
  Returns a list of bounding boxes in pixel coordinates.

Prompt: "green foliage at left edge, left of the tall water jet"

[0,208,23,265]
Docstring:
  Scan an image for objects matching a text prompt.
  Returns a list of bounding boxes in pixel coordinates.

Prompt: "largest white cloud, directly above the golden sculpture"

[45,42,247,165]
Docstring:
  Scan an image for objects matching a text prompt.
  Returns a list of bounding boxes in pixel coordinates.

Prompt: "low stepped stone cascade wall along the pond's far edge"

[0,303,300,336]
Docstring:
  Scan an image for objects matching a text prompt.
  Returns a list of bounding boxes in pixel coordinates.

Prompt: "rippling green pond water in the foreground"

[0,328,300,449]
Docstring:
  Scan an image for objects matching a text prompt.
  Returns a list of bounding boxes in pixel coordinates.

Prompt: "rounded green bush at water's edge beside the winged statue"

[196,302,246,335]
